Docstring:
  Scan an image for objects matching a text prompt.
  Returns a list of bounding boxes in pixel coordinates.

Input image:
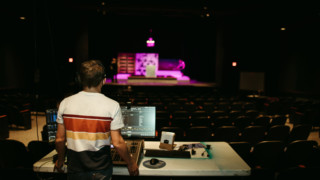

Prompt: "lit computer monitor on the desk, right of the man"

[121,106,156,139]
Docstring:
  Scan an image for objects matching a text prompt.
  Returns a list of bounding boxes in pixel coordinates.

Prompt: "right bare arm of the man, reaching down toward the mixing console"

[111,130,139,176]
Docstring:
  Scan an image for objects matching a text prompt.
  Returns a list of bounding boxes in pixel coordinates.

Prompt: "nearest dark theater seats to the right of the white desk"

[229,140,320,180]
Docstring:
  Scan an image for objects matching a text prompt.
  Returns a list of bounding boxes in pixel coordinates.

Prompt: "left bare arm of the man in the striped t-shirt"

[55,123,66,173]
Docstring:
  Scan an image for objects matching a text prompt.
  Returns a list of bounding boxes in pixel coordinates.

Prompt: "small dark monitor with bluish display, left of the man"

[46,109,58,142]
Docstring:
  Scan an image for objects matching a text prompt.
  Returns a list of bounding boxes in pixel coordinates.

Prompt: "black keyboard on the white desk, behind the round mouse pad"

[144,149,191,158]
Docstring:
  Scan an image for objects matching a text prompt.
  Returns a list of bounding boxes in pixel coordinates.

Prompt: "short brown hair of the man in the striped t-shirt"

[79,60,105,88]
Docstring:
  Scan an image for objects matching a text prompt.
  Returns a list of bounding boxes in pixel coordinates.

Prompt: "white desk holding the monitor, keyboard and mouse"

[33,141,251,176]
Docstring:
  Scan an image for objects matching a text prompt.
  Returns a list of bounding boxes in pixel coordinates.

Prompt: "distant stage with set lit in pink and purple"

[105,52,217,87]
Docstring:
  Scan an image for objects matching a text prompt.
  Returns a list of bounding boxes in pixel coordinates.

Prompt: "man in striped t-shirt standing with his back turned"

[55,60,139,180]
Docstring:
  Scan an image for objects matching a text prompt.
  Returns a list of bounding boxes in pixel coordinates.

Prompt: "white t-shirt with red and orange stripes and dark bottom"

[57,91,123,173]
